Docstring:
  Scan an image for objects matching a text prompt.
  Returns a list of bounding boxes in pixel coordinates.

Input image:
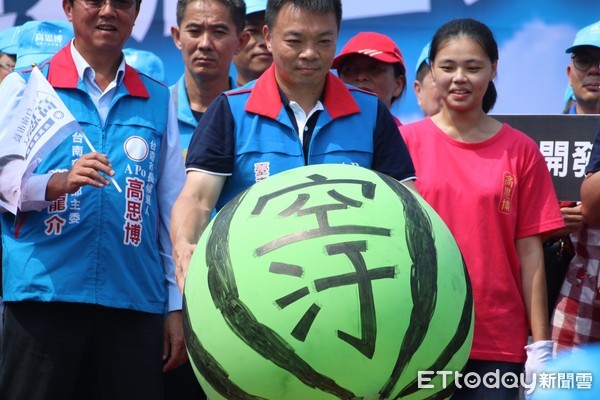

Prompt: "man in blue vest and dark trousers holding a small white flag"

[0,0,187,400]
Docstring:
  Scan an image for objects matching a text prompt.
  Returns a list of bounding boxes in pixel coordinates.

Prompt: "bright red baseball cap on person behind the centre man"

[331,32,404,69]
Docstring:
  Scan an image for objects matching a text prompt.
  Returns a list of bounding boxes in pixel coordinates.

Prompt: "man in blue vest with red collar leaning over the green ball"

[171,0,415,289]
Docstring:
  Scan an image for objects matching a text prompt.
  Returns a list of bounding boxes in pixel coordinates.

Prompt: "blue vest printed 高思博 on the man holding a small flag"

[2,48,169,314]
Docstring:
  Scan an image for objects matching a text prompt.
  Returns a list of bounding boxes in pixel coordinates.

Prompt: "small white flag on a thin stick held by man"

[0,67,81,214]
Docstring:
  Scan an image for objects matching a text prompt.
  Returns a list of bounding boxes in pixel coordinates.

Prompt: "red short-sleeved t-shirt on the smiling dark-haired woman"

[400,118,564,362]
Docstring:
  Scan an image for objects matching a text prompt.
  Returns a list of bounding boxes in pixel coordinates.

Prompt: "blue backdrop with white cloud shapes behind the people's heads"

[0,0,600,123]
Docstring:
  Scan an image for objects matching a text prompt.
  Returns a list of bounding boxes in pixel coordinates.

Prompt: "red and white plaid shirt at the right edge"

[552,226,600,351]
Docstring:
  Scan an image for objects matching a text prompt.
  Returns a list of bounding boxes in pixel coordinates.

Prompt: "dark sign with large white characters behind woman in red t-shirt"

[494,114,600,201]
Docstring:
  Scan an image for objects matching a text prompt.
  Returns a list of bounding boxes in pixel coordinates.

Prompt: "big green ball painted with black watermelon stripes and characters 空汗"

[184,165,473,400]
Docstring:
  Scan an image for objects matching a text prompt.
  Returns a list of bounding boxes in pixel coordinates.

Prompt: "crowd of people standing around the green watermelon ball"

[0,0,600,399]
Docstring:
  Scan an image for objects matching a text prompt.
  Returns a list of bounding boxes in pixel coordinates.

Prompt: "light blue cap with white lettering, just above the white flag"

[15,21,73,68]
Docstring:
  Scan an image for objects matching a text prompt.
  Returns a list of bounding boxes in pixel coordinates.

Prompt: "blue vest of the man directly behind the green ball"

[217,75,378,210]
